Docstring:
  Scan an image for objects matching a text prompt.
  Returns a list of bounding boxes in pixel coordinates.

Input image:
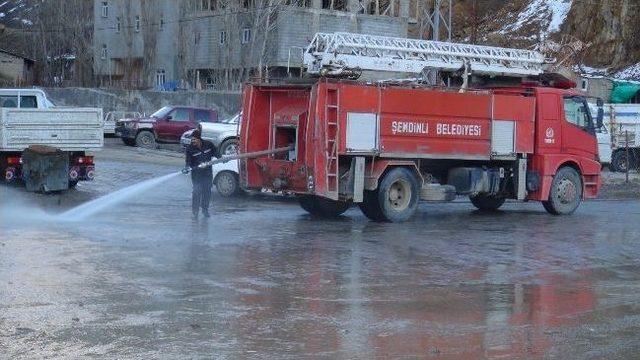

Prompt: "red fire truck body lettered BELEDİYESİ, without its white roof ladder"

[241,79,600,221]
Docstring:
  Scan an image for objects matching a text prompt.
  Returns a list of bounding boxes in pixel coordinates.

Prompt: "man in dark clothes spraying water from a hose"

[185,128,220,218]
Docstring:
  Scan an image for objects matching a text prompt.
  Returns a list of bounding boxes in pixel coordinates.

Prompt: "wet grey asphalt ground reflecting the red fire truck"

[0,141,640,359]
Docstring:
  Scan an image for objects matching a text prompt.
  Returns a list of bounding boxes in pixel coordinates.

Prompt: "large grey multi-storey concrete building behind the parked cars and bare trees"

[94,0,412,91]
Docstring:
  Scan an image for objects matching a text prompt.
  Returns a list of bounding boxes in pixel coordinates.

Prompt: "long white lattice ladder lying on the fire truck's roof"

[303,32,545,77]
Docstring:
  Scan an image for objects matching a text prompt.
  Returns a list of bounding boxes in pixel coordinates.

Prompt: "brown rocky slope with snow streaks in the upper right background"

[454,0,640,80]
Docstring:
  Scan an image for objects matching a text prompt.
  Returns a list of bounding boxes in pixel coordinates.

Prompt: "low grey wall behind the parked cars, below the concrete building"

[44,88,241,117]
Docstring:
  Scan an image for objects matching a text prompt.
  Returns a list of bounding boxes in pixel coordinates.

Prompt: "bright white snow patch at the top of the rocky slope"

[499,0,573,38]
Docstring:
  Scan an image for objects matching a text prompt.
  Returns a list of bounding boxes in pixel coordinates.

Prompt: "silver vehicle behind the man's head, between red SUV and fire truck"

[180,112,242,155]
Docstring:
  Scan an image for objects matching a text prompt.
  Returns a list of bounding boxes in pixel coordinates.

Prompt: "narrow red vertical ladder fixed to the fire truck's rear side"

[324,83,340,200]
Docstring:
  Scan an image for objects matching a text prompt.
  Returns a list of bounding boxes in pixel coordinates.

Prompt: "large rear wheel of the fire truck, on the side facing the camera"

[360,167,420,222]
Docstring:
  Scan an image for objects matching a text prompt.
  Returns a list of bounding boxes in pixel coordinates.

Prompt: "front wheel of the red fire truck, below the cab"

[542,166,582,215]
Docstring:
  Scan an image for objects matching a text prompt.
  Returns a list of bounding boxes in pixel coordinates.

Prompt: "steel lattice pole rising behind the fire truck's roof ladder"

[420,0,453,85]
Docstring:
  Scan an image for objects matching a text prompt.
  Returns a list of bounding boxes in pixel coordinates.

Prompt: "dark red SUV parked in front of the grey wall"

[115,106,218,148]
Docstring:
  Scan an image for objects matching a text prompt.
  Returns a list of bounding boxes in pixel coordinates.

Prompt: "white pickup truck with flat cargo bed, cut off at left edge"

[0,89,104,187]
